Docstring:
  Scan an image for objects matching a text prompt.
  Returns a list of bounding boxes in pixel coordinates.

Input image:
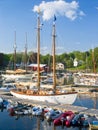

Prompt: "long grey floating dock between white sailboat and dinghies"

[0,93,98,116]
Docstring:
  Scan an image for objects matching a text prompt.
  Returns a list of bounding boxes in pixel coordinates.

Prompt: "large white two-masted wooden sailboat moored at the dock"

[11,13,77,104]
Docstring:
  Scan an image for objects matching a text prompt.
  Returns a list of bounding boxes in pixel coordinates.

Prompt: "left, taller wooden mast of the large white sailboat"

[37,11,40,90]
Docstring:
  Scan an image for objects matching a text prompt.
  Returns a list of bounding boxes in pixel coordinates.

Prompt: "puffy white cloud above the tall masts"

[33,0,85,20]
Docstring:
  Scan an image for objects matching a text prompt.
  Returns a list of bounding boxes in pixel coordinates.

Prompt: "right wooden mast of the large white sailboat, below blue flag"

[52,18,56,92]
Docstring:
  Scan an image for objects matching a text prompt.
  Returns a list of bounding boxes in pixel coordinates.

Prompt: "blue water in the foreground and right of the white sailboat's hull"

[0,95,98,130]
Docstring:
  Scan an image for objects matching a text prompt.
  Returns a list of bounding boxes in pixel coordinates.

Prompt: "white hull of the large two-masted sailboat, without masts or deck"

[11,91,77,104]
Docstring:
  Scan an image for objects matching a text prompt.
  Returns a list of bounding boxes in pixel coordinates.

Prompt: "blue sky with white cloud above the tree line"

[0,0,98,54]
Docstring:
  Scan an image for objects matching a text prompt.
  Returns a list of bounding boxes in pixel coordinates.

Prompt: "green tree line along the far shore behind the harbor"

[0,47,98,72]
